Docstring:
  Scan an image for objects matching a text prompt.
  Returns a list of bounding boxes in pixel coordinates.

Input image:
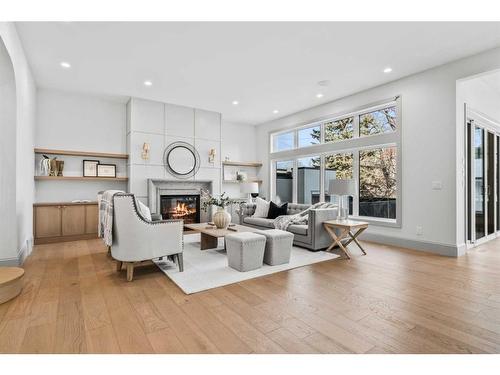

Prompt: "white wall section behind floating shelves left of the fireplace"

[34,88,127,202]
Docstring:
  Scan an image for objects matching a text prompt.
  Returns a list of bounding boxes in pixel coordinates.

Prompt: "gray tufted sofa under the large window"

[239,203,337,251]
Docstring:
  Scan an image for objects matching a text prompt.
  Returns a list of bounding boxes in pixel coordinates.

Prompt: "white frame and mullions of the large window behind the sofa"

[268,95,403,228]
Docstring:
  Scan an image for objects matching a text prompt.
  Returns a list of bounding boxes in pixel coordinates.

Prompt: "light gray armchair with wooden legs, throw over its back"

[111,194,184,281]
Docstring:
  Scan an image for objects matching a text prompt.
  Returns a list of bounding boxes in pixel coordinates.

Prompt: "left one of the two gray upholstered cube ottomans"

[224,232,266,272]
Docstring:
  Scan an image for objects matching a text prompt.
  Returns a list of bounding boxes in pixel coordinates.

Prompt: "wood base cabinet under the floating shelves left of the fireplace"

[33,202,99,244]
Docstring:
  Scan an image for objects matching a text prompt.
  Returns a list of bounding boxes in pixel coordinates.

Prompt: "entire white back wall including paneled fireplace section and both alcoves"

[34,92,256,207]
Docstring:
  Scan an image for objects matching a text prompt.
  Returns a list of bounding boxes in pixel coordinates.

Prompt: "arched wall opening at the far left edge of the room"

[0,37,18,265]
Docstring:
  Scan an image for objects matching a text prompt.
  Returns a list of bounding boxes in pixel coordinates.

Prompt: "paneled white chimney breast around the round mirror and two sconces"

[127,98,221,204]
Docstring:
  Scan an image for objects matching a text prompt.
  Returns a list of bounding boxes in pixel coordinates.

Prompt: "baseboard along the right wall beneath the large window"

[360,232,466,257]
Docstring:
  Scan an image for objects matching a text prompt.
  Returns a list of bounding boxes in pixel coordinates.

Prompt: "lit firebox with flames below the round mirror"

[160,195,200,224]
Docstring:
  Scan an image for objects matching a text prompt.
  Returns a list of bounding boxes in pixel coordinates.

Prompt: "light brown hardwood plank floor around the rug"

[0,240,500,353]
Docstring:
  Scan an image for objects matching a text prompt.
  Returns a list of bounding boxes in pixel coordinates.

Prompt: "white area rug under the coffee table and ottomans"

[156,234,339,294]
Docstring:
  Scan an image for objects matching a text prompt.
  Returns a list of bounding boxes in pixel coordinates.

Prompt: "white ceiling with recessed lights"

[17,22,500,124]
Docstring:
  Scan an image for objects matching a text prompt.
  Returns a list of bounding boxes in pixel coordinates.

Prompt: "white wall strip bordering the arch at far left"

[0,22,36,262]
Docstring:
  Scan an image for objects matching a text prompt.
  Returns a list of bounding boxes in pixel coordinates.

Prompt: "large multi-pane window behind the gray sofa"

[270,98,401,225]
